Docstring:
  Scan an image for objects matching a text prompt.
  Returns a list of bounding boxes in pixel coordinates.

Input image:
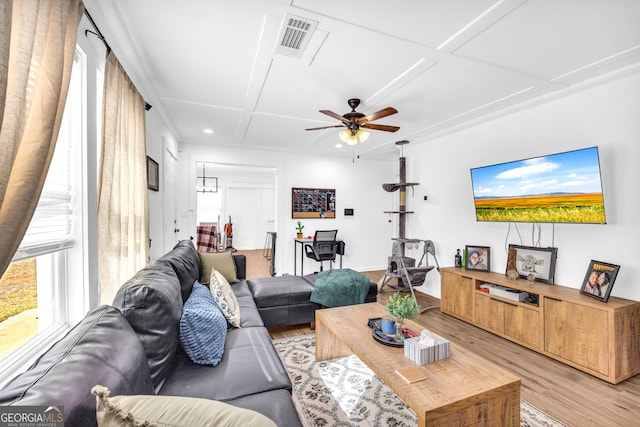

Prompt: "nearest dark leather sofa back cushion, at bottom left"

[0,305,154,426]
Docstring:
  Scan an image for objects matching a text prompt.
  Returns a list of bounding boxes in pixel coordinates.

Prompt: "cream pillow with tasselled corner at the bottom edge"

[92,385,276,427]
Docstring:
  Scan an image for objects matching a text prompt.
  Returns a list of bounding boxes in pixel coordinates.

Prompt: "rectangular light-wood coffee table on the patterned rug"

[316,303,520,426]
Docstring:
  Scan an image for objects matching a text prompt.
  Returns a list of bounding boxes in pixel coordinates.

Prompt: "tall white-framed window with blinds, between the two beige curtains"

[0,48,88,377]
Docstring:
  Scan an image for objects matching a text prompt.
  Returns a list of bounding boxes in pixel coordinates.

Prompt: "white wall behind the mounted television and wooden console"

[405,69,640,300]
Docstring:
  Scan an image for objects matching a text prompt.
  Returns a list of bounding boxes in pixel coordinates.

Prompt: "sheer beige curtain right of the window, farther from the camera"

[98,52,149,304]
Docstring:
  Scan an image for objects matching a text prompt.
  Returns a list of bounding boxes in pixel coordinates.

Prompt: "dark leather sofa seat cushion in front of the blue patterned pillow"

[158,327,291,401]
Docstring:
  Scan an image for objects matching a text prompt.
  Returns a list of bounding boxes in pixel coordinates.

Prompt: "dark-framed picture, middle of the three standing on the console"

[509,244,558,284]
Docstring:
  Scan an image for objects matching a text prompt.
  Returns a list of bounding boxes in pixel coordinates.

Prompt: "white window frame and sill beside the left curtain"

[0,46,92,387]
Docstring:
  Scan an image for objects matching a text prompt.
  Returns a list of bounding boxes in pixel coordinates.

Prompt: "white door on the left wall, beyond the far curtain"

[162,142,179,253]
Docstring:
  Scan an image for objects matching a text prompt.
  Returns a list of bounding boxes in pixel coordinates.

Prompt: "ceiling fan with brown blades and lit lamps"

[305,98,400,145]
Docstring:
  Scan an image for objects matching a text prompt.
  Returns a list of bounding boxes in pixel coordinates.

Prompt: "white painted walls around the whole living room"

[147,70,640,300]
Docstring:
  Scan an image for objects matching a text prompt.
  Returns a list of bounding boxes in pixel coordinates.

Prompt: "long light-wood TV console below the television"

[440,267,640,384]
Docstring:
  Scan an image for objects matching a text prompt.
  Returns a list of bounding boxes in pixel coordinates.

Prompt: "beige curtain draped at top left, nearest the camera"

[0,0,84,275]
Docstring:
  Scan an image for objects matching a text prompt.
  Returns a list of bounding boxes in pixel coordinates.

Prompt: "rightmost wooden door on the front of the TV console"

[544,297,609,375]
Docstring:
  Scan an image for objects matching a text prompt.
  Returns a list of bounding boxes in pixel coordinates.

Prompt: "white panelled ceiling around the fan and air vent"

[84,0,640,158]
